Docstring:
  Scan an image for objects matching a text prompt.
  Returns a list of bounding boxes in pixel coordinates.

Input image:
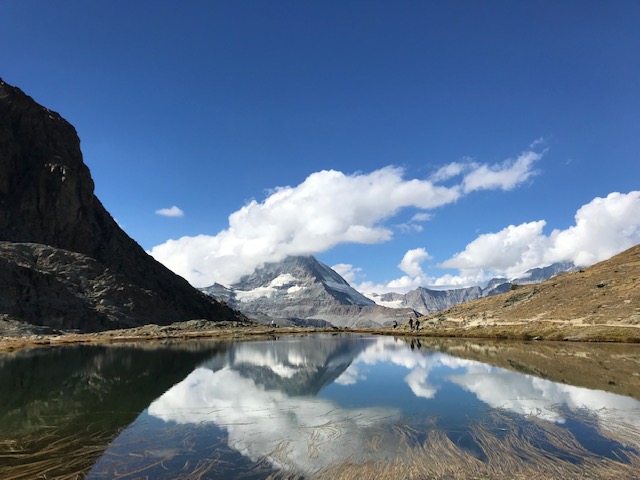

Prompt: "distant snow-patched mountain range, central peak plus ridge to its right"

[201,256,574,327]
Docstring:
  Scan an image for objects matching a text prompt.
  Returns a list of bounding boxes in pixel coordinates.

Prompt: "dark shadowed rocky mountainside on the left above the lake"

[0,79,238,331]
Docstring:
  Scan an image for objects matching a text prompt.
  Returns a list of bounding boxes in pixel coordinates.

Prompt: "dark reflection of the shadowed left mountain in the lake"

[0,342,230,479]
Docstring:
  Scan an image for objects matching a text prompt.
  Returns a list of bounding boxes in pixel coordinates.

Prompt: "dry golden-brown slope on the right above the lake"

[420,245,640,341]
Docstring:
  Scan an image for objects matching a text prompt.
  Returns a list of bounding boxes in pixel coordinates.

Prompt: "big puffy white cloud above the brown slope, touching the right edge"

[440,191,640,278]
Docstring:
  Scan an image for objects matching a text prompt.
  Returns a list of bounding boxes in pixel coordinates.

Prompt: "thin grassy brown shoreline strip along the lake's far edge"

[0,320,640,353]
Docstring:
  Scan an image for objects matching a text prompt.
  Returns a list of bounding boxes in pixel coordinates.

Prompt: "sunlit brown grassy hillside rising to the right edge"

[425,245,640,337]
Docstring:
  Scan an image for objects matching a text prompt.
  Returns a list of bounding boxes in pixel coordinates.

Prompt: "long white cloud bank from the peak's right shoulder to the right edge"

[349,191,640,296]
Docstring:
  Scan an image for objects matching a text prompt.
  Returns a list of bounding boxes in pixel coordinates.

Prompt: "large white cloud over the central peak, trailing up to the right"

[149,152,540,286]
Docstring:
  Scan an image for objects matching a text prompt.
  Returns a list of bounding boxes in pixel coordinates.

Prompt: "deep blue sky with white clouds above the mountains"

[0,0,640,291]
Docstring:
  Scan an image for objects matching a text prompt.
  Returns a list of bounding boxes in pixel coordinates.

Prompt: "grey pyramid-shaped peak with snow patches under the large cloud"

[202,256,416,327]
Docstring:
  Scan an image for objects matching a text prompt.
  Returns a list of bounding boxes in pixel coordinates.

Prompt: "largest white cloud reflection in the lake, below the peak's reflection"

[148,368,400,472]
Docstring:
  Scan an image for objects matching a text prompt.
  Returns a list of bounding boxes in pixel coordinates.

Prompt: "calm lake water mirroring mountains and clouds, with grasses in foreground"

[0,335,640,479]
